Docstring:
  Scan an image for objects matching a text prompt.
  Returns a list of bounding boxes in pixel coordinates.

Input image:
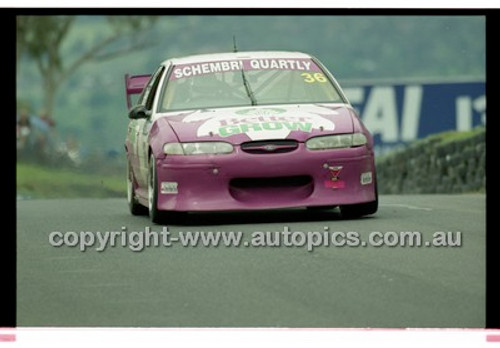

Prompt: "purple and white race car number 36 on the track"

[125,51,378,223]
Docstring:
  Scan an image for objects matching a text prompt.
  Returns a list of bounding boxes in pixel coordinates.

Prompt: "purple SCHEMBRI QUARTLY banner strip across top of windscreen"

[170,58,321,80]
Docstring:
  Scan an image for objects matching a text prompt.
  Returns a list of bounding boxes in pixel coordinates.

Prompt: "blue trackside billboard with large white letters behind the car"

[343,81,486,154]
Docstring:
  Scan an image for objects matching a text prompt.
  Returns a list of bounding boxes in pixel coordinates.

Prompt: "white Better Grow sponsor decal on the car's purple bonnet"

[182,105,337,140]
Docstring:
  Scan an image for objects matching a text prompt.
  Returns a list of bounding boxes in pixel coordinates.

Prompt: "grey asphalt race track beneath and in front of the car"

[17,194,486,328]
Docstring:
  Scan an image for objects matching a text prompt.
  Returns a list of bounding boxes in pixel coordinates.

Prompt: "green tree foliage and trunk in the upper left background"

[16,16,157,115]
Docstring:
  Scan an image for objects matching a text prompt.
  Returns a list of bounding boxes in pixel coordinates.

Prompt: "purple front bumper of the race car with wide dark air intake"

[156,144,376,211]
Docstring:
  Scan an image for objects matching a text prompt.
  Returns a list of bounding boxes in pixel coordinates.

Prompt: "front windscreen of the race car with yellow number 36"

[159,58,343,112]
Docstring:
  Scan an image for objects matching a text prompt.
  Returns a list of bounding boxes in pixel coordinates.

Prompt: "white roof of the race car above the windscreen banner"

[163,51,311,65]
